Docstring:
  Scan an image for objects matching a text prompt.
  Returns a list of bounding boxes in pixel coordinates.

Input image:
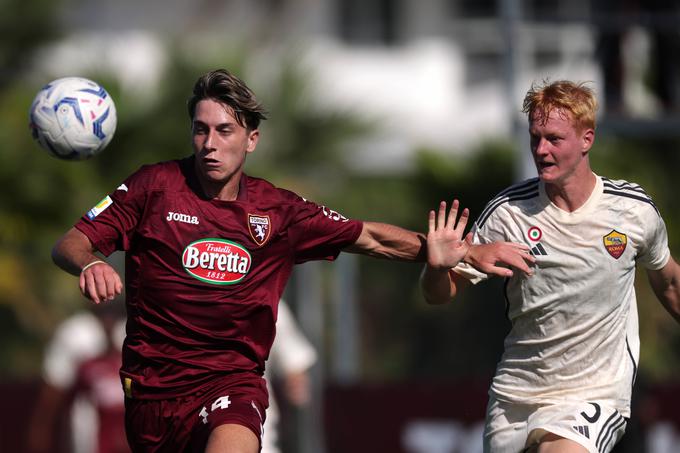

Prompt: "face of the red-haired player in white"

[529,110,595,185]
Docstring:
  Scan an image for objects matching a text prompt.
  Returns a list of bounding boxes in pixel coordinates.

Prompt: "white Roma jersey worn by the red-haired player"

[456,177,670,417]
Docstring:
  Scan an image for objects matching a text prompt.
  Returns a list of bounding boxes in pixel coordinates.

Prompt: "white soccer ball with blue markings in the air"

[29,77,117,160]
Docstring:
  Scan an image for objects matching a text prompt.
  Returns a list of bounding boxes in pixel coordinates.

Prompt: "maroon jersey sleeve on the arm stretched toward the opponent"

[288,198,363,263]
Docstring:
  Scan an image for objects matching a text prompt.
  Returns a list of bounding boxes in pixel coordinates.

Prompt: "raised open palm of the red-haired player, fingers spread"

[427,200,470,270]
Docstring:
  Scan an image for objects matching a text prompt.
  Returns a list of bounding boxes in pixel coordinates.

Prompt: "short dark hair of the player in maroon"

[187,69,267,130]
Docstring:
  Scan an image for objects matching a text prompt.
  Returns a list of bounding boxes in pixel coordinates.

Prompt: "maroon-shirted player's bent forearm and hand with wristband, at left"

[52,228,123,304]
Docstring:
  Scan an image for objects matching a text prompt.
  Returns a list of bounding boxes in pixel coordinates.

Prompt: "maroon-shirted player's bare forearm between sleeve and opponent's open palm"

[345,222,427,262]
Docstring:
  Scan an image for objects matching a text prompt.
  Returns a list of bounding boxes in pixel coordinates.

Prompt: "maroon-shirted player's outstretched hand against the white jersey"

[464,237,536,277]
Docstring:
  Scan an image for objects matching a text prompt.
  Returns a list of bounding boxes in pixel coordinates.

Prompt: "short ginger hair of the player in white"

[522,80,598,130]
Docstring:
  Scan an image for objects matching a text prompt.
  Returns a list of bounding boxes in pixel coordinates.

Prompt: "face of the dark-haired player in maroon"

[191,99,259,188]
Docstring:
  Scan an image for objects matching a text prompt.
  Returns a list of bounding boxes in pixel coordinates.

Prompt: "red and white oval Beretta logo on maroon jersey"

[182,238,252,285]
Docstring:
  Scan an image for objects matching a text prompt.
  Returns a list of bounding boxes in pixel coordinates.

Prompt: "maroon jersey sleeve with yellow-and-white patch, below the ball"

[75,167,148,256]
